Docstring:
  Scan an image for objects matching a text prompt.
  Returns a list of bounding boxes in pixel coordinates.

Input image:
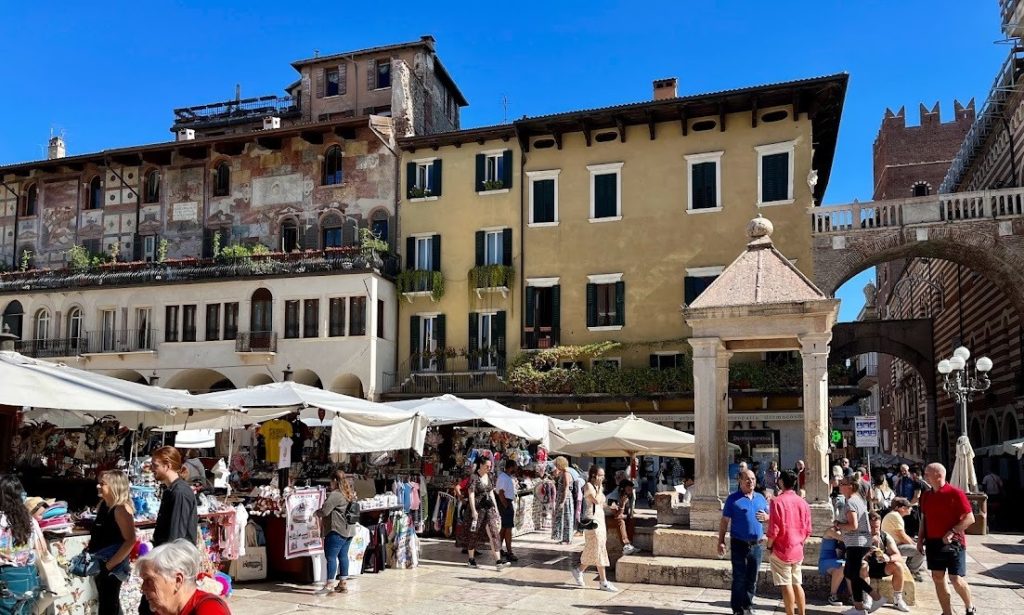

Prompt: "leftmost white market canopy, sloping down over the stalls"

[0,351,236,427]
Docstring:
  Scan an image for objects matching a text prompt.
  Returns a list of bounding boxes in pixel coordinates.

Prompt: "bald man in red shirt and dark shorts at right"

[918,464,976,615]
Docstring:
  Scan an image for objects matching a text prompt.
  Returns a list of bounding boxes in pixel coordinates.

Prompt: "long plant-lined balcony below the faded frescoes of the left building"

[0,247,398,293]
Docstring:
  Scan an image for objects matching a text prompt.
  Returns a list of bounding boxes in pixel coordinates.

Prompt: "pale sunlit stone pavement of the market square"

[229,534,1024,615]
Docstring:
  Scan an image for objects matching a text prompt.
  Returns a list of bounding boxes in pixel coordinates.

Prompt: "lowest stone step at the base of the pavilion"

[615,555,915,606]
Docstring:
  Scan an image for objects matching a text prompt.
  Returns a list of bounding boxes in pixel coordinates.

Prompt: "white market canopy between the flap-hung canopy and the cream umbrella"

[388,395,551,448]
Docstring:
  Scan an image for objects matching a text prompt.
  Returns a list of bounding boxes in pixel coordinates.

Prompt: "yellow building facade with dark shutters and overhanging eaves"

[391,75,847,421]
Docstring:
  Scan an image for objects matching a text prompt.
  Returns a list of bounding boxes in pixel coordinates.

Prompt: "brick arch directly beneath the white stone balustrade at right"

[813,220,1024,315]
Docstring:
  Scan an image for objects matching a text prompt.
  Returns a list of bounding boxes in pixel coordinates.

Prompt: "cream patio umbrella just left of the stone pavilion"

[559,414,695,457]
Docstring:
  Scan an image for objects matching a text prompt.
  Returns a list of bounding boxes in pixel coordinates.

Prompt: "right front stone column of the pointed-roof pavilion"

[800,333,833,532]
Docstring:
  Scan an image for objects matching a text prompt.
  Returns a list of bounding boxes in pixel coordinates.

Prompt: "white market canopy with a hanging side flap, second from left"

[189,382,428,454]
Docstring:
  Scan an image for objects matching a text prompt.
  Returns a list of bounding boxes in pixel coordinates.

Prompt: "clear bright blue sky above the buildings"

[0,0,1009,320]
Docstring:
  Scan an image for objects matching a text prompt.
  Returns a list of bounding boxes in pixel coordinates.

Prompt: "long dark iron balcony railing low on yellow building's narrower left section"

[384,352,509,396]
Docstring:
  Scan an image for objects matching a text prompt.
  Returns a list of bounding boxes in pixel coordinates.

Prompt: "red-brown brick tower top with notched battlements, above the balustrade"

[873,98,974,201]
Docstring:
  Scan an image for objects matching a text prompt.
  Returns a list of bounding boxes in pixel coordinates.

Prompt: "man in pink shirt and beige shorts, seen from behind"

[767,470,811,615]
